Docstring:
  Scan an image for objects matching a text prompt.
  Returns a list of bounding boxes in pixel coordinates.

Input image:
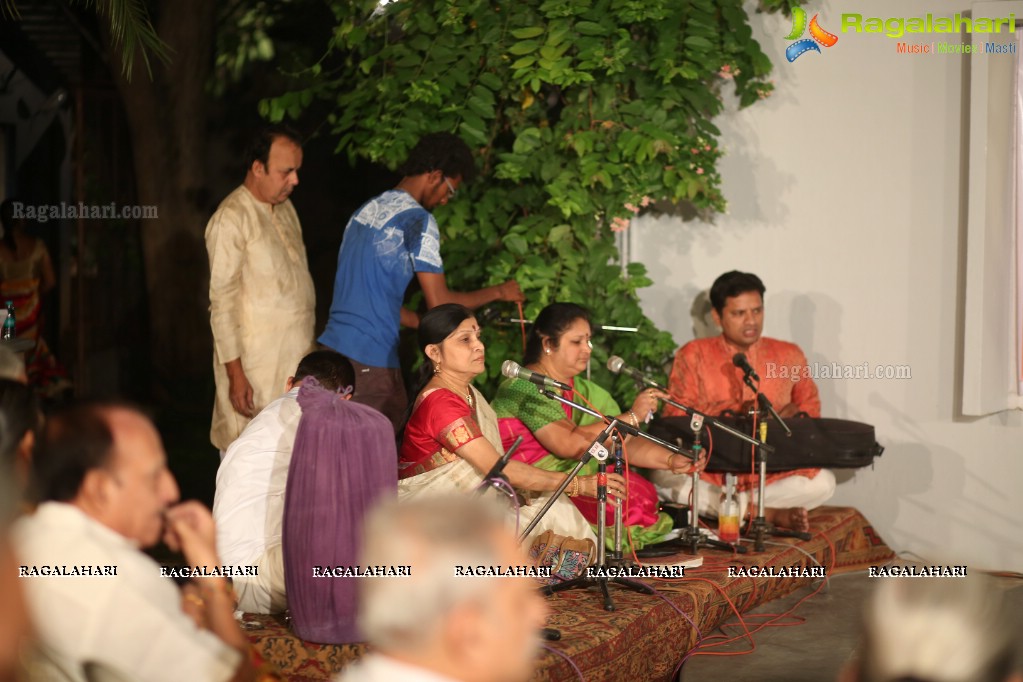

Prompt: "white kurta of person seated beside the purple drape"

[213,388,302,613]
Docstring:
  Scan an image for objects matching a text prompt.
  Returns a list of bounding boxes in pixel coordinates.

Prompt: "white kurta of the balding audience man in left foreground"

[13,502,240,682]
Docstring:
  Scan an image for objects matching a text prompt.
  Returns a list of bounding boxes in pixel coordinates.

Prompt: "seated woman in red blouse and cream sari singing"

[398,304,609,542]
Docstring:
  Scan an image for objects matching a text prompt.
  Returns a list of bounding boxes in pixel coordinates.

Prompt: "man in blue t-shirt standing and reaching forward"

[319,133,523,428]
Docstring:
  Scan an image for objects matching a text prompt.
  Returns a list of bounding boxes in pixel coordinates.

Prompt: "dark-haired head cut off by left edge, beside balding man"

[0,378,43,499]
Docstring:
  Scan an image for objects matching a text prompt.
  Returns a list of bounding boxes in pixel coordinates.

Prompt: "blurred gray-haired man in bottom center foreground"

[338,498,546,682]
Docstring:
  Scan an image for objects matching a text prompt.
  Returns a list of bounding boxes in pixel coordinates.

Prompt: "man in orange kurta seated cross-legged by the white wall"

[652,271,835,531]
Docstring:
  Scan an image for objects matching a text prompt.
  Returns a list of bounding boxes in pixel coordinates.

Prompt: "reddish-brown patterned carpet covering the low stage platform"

[244,507,894,681]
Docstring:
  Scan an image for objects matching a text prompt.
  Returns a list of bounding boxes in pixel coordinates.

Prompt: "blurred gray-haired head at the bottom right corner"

[843,576,1023,682]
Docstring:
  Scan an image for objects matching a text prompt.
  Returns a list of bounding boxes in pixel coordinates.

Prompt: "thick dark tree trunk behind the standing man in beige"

[103,0,215,402]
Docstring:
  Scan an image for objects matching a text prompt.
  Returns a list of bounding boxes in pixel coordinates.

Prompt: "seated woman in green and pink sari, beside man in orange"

[494,303,704,551]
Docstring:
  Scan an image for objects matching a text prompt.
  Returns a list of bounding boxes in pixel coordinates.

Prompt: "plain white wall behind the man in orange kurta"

[629,0,1023,571]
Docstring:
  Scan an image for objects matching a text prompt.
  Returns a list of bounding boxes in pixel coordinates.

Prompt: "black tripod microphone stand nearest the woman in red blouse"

[520,388,697,611]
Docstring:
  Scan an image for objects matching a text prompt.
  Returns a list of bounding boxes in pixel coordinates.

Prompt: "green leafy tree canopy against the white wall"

[261,0,801,395]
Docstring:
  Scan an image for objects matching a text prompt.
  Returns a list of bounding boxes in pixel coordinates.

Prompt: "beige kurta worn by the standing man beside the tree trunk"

[206,185,316,450]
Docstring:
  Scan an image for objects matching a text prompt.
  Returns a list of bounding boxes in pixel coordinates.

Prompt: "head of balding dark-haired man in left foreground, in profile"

[33,403,178,547]
